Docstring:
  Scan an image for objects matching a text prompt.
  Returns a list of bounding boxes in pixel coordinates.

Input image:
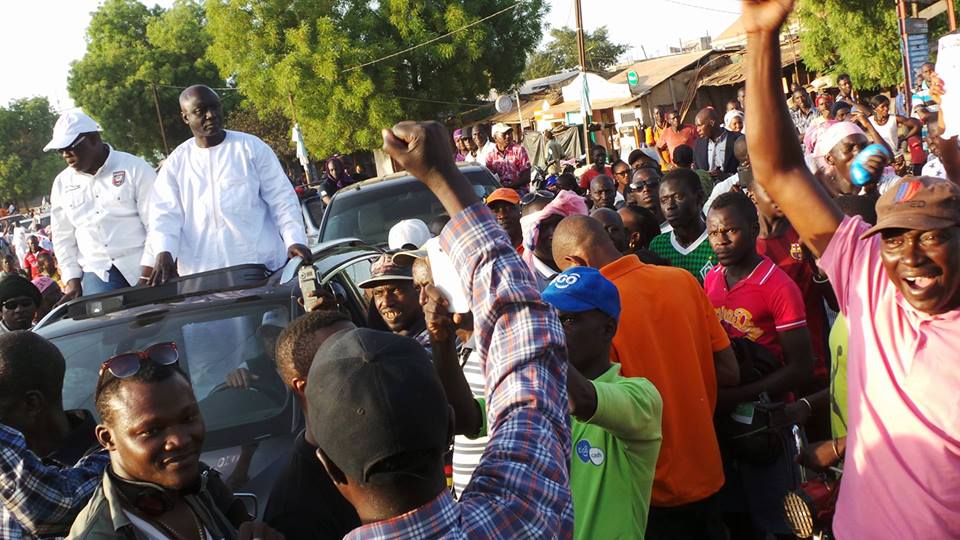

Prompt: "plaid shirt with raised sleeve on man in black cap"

[348,203,573,539]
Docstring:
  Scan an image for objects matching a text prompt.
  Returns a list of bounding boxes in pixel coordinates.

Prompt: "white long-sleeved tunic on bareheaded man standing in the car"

[149,131,307,276]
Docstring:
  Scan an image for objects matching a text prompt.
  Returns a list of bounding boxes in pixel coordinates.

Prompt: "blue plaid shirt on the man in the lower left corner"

[0,424,110,538]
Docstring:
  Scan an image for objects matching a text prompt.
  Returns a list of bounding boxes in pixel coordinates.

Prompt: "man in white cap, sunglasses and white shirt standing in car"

[44,109,156,301]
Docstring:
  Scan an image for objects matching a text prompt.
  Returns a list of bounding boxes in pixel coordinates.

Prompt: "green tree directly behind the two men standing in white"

[67,0,235,160]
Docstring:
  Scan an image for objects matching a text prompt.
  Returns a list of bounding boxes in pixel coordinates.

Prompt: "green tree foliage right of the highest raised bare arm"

[797,0,903,88]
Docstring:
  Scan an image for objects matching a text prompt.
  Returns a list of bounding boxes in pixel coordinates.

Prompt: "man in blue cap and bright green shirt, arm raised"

[420,260,663,540]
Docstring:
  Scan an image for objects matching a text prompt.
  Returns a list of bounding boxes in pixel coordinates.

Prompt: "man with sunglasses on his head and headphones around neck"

[68,343,282,540]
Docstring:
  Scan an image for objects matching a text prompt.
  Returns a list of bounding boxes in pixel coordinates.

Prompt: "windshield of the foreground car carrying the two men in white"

[48,301,290,432]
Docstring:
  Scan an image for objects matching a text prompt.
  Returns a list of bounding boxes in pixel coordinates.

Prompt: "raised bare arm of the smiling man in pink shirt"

[742,0,843,257]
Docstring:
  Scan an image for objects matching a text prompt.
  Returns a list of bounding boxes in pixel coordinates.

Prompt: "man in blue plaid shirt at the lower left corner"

[0,331,110,540]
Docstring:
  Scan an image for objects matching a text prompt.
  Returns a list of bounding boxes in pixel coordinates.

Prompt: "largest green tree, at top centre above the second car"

[206,0,546,156]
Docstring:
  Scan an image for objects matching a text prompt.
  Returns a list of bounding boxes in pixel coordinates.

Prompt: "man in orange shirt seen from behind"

[553,216,740,540]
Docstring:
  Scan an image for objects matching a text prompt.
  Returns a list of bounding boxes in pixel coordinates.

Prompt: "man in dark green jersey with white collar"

[650,169,717,285]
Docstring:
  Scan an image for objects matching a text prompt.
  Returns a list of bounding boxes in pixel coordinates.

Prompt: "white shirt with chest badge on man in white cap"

[50,148,157,285]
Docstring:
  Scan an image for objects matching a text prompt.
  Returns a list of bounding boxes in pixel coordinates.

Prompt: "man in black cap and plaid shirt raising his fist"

[306,122,573,539]
